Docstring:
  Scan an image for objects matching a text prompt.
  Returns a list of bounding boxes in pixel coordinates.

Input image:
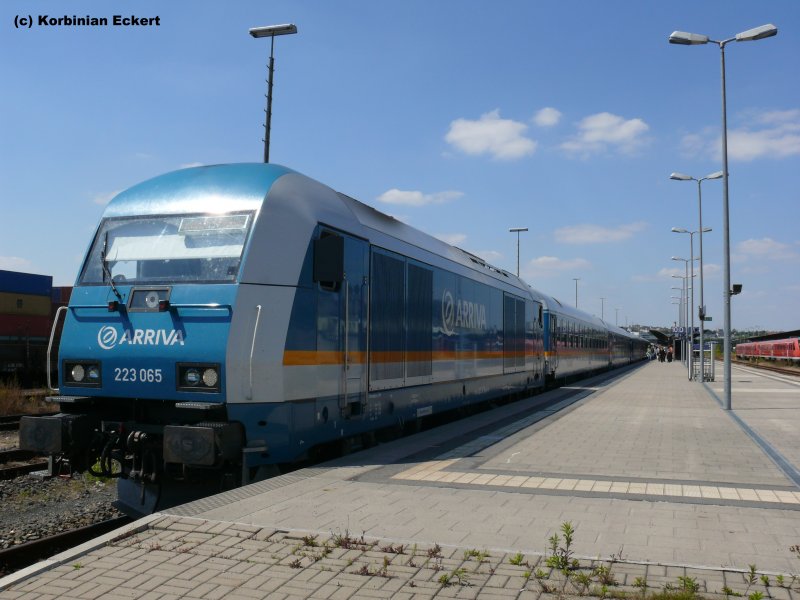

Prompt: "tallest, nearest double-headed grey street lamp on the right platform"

[669,23,778,410]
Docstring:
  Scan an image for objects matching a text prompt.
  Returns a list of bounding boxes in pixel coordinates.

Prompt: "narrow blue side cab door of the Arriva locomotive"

[339,236,369,417]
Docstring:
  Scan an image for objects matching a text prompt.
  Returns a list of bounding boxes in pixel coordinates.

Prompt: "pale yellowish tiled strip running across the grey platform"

[392,459,800,505]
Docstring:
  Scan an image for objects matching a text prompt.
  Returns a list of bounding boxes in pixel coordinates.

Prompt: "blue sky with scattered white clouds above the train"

[0,0,800,331]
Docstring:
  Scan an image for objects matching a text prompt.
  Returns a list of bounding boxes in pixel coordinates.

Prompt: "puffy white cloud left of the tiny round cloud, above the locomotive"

[444,109,537,160]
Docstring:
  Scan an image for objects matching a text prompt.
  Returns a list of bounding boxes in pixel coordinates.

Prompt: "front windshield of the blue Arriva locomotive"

[81,212,253,284]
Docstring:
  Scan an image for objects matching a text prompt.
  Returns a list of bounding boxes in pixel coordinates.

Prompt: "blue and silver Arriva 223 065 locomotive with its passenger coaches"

[20,164,648,514]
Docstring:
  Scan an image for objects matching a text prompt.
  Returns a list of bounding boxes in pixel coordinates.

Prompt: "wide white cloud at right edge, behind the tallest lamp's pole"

[681,109,800,161]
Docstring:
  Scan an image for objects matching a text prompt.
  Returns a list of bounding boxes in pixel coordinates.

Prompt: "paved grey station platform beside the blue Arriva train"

[0,362,800,600]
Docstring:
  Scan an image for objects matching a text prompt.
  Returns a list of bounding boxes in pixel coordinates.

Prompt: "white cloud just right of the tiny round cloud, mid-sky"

[561,112,650,155]
